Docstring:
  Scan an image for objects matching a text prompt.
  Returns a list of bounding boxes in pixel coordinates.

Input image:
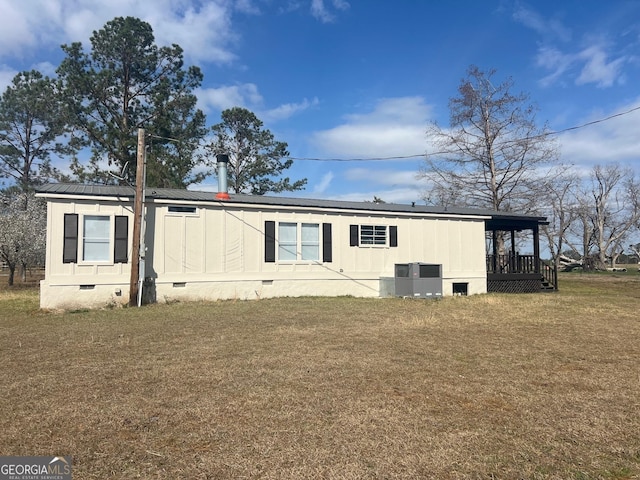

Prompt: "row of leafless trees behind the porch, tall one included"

[419,66,640,270]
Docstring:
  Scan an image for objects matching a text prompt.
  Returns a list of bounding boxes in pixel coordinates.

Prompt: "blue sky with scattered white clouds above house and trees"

[0,0,640,203]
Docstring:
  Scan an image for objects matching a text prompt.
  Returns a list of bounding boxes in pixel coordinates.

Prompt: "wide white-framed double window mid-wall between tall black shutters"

[278,222,320,262]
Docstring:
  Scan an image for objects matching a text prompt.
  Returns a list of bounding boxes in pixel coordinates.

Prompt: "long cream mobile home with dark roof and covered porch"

[38,171,556,309]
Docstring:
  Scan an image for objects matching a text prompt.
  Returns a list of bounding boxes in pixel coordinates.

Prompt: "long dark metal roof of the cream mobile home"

[36,183,546,225]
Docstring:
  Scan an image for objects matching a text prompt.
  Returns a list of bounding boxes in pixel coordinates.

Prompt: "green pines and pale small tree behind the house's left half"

[0,17,306,283]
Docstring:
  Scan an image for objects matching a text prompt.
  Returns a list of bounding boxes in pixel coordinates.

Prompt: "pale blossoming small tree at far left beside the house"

[0,193,47,285]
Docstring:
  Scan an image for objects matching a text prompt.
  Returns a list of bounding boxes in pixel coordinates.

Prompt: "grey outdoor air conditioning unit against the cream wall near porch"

[394,262,442,298]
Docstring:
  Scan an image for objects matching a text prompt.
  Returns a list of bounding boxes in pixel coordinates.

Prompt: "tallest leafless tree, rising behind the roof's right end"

[418,66,558,212]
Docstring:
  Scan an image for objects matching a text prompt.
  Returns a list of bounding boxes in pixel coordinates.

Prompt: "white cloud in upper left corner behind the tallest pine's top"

[0,0,238,63]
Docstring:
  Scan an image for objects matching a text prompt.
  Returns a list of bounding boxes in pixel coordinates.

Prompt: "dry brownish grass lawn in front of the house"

[0,273,640,480]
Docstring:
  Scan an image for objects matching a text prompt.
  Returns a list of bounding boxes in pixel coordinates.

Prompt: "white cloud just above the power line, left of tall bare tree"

[311,97,430,158]
